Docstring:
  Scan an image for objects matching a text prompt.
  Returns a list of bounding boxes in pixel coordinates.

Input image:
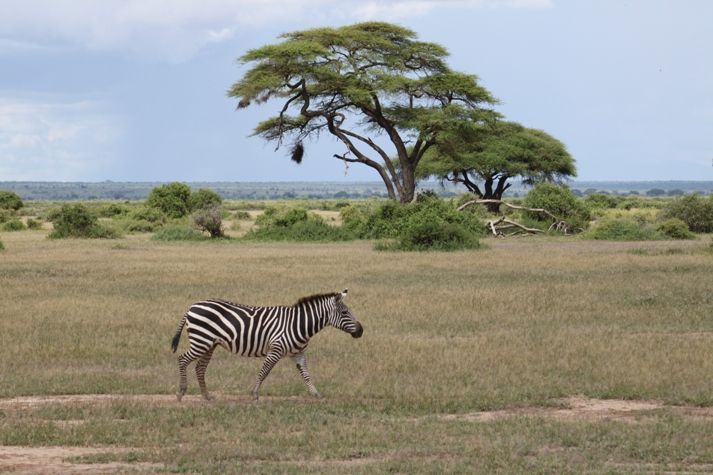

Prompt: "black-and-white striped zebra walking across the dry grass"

[171,289,364,401]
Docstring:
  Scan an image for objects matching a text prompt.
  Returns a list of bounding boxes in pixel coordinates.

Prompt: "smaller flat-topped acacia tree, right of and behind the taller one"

[417,121,577,212]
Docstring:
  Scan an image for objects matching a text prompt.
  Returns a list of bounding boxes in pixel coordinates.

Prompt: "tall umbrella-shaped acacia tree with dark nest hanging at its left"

[228,22,495,202]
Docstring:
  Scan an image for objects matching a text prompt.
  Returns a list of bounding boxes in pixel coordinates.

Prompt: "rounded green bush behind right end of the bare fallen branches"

[523,183,590,228]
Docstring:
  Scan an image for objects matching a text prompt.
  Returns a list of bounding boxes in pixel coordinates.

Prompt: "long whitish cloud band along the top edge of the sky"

[0,0,553,62]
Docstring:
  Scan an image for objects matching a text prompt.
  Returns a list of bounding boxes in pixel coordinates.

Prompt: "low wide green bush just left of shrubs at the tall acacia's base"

[245,207,354,241]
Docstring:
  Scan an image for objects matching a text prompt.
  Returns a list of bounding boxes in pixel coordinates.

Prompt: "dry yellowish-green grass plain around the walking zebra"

[0,226,713,473]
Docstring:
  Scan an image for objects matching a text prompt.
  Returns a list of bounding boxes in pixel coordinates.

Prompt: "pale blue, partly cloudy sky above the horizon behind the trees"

[0,0,713,182]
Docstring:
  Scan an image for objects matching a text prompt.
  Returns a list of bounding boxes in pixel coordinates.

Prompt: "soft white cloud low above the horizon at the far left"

[0,97,121,181]
